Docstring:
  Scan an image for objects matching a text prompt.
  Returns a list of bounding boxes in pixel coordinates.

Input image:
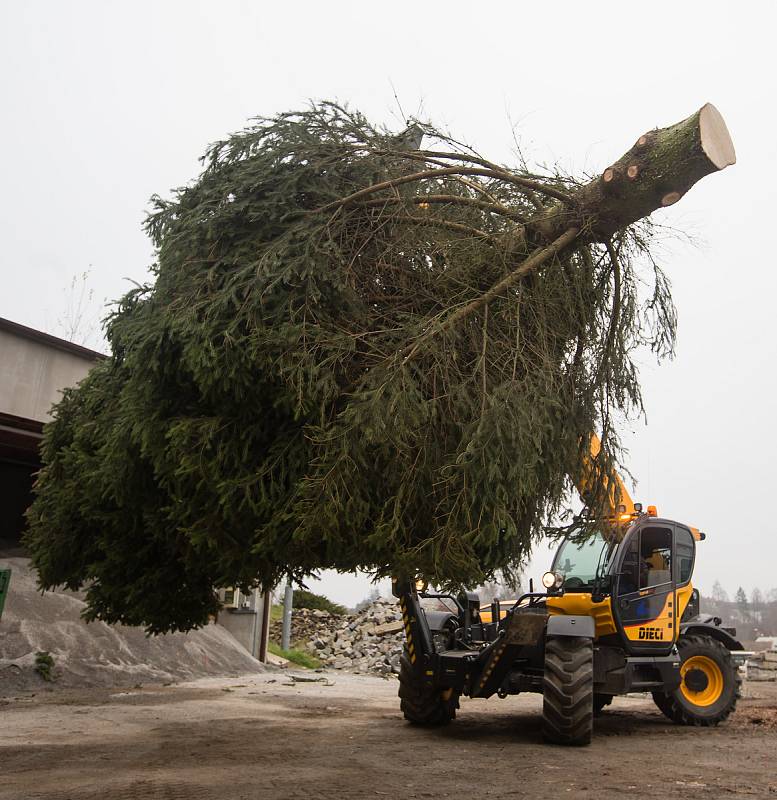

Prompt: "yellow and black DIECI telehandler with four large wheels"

[393,438,744,745]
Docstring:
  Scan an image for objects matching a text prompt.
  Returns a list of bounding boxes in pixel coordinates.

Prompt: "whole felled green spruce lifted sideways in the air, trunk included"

[27,103,733,633]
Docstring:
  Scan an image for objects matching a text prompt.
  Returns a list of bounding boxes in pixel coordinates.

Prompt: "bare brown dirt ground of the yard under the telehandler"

[0,671,777,800]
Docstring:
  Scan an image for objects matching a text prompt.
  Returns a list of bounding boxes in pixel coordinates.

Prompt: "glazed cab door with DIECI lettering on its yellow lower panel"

[613,520,678,655]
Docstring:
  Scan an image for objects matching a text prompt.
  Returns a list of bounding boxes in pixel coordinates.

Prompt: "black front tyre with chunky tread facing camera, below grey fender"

[542,636,594,745]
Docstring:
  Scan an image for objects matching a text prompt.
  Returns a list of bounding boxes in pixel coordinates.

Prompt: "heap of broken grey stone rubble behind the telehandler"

[270,598,404,675]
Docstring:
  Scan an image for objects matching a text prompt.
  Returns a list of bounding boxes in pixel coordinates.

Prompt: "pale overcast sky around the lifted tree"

[0,0,777,604]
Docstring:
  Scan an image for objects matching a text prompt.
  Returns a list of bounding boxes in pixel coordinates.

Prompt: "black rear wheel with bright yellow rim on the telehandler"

[653,634,742,727]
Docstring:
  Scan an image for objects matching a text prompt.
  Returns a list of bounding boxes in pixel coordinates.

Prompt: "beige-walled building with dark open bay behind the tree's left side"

[0,317,105,554]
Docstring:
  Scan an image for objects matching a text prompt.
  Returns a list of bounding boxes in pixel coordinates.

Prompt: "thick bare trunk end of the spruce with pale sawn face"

[527,103,736,241]
